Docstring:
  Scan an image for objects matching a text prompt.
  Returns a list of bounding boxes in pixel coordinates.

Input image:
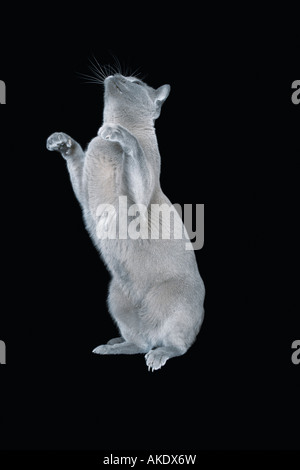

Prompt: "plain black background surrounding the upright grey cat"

[0,6,300,451]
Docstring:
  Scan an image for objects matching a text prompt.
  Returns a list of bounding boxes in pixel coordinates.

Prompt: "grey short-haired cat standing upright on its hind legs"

[47,70,205,371]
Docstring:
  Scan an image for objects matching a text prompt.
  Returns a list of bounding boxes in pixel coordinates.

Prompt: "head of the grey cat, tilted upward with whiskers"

[104,74,170,127]
